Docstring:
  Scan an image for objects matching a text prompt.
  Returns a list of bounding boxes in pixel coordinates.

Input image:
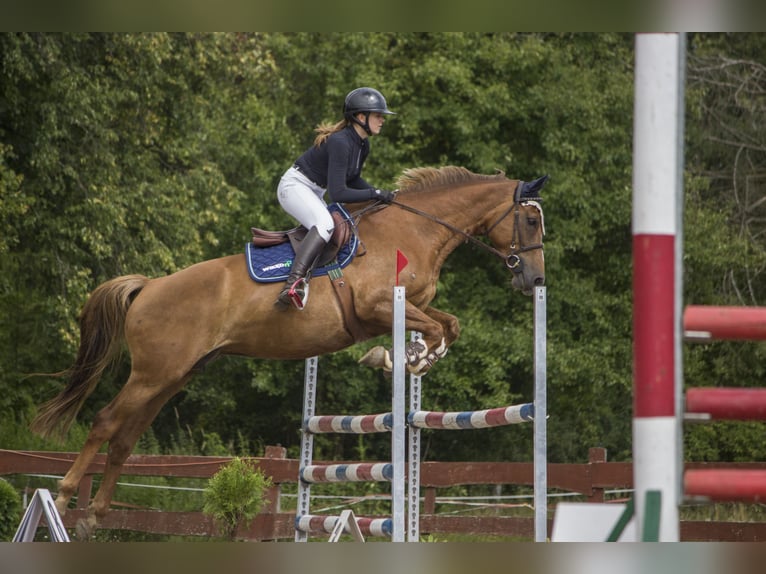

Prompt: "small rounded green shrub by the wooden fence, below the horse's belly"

[203,457,271,540]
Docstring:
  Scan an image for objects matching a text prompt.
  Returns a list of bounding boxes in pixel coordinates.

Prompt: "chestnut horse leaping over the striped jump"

[31,166,548,538]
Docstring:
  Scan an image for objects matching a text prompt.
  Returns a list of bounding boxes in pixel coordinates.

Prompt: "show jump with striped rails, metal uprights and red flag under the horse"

[295,252,548,542]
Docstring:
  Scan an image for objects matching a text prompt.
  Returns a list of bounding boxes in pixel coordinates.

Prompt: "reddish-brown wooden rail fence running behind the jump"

[0,447,766,542]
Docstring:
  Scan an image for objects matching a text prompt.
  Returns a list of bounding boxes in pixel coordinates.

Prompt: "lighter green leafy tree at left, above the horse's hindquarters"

[0,34,276,436]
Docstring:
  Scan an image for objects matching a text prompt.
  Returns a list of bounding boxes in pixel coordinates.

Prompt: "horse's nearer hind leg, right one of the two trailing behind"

[77,375,188,539]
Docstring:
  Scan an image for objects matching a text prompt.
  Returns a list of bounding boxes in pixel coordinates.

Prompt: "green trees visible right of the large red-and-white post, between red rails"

[684,34,766,461]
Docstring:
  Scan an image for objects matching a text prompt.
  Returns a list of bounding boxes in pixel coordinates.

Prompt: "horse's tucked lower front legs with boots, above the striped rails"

[359,303,460,375]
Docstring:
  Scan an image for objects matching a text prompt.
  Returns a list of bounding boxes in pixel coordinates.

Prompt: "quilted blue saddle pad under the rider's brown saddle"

[245,203,359,283]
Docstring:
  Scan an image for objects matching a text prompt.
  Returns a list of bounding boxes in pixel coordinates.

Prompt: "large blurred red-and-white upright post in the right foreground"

[633,34,683,542]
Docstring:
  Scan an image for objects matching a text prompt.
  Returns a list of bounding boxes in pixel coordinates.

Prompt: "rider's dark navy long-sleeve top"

[295,125,377,203]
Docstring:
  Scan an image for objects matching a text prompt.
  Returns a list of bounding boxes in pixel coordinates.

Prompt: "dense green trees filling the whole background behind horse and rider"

[0,33,766,472]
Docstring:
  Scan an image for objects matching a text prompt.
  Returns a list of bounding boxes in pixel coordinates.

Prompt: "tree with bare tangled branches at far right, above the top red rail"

[688,34,766,305]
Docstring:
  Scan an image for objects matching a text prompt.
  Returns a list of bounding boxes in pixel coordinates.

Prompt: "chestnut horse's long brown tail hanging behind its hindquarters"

[30,275,149,438]
